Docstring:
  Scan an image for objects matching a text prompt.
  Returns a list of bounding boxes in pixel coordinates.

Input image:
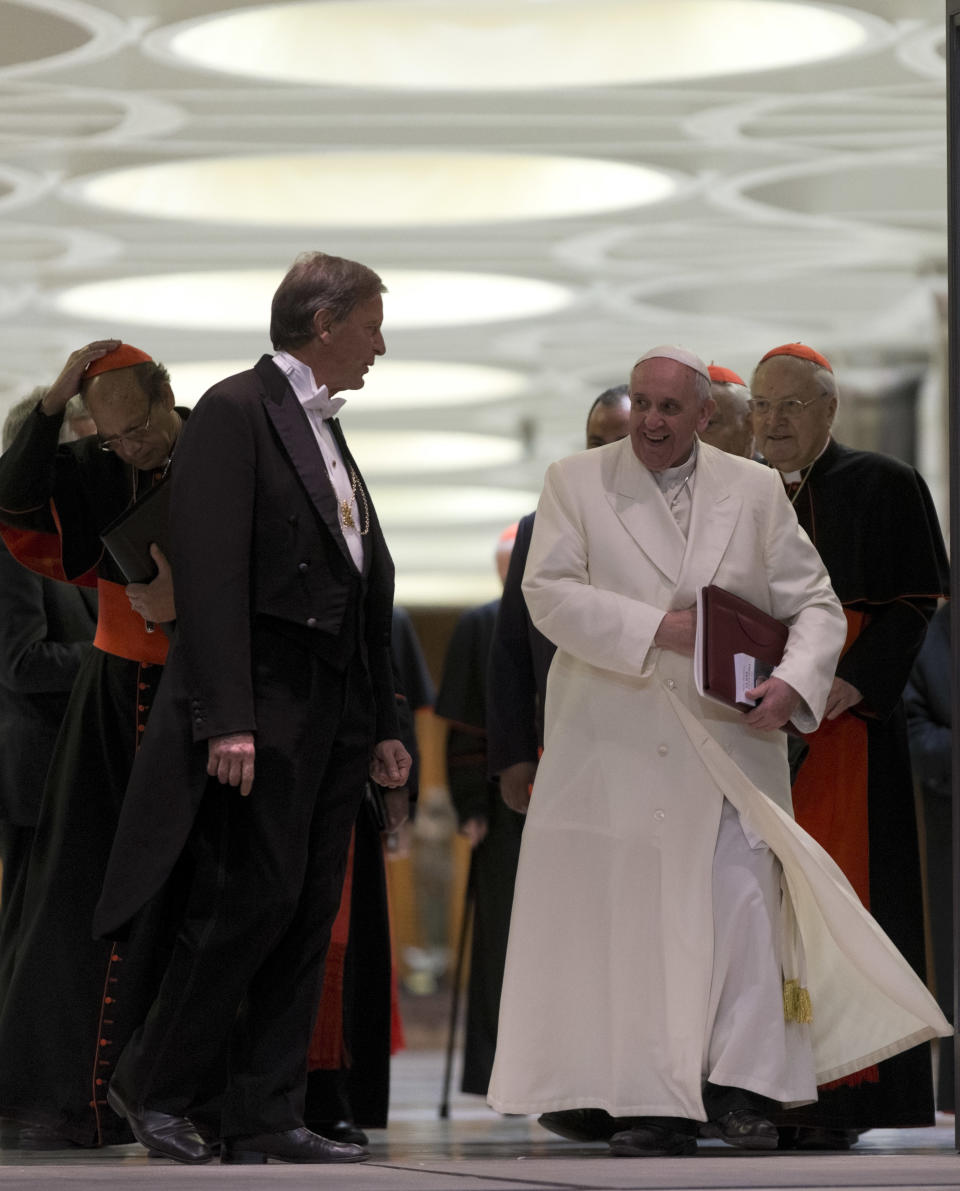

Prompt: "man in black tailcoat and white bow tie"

[94,252,410,1162]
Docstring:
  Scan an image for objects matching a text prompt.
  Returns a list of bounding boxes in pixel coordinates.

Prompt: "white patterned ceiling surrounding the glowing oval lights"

[0,0,946,604]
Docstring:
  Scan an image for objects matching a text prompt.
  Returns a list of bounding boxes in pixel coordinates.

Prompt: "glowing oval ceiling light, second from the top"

[71,150,678,227]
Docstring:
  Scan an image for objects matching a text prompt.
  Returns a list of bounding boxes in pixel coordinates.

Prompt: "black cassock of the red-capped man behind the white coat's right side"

[778,441,948,1130]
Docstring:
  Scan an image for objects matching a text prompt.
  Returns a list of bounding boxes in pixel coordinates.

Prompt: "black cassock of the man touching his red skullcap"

[0,410,187,1146]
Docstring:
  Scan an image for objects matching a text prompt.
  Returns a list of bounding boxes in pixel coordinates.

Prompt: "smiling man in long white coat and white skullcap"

[488,347,953,1155]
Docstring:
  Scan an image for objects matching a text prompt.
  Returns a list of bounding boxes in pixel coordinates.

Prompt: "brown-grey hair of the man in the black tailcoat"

[270,252,387,351]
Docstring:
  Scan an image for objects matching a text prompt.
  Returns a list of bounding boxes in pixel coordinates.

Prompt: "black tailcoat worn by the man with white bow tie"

[94,356,398,936]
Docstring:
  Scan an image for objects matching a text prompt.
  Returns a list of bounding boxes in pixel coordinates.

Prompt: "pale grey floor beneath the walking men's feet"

[0,1049,960,1191]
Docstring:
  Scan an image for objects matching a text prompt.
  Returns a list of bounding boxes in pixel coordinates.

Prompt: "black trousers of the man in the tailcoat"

[116,628,375,1137]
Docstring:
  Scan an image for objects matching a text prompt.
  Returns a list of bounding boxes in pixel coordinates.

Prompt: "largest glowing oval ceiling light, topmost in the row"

[150,0,883,91]
